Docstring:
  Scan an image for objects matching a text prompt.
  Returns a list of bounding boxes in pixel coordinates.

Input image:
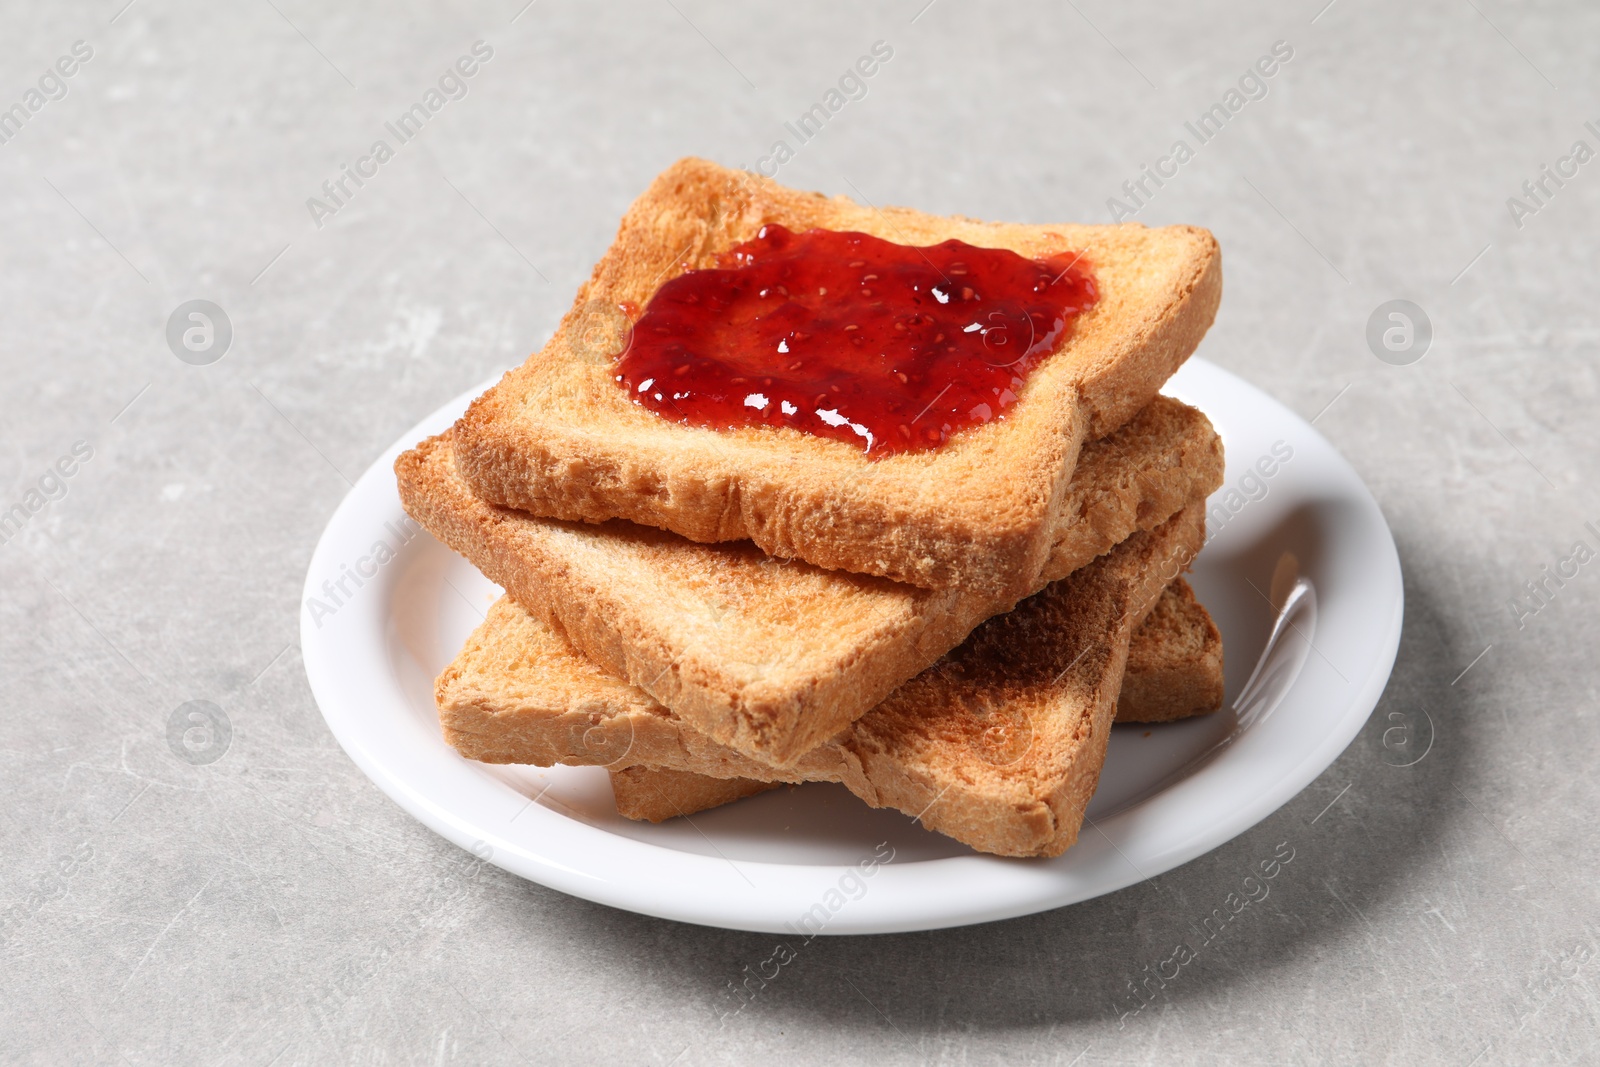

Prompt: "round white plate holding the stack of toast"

[301,360,1402,934]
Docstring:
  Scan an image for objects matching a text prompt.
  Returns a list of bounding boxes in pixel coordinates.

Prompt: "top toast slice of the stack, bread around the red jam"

[454,158,1222,600]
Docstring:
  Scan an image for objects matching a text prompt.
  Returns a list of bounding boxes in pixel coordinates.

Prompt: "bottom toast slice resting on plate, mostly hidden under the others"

[611,577,1222,822]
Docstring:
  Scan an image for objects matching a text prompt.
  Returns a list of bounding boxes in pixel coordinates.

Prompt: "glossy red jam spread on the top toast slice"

[604,224,1096,456]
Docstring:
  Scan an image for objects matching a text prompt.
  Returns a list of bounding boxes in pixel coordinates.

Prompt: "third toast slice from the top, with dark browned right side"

[435,504,1205,856]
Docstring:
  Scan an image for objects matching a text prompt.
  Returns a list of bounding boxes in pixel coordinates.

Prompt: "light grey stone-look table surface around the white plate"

[0,0,1600,1067]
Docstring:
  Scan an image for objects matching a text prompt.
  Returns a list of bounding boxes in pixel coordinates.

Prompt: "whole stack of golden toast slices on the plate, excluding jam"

[395,160,1222,856]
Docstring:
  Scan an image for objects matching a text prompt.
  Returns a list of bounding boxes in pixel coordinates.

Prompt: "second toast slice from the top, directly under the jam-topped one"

[395,397,1222,763]
